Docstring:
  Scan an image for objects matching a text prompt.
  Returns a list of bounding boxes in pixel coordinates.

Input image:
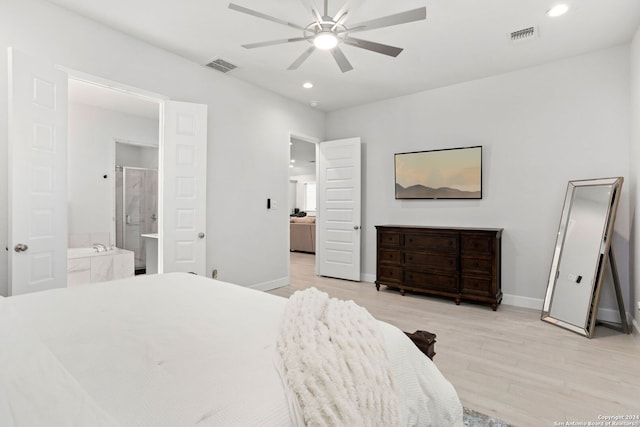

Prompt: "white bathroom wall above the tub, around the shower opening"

[67,103,159,239]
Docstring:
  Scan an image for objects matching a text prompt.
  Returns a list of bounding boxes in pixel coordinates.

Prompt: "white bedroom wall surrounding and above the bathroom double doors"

[0,0,325,294]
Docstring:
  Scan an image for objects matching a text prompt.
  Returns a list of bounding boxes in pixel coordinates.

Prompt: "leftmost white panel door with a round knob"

[8,48,67,295]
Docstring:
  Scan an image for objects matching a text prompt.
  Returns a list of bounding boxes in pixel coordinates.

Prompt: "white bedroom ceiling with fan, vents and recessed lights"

[48,0,640,111]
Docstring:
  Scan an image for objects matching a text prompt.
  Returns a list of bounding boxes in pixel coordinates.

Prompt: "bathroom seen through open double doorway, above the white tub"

[68,78,160,279]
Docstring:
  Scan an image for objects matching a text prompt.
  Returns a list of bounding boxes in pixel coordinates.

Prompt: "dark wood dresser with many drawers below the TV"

[376,225,502,311]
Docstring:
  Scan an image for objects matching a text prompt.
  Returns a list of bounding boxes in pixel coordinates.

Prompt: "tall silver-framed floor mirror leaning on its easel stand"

[542,177,629,338]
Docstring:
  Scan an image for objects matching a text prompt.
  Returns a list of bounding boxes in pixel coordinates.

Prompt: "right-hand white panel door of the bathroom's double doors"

[158,101,207,275]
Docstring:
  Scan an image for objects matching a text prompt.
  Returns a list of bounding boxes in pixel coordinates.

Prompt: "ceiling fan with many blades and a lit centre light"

[229,0,427,73]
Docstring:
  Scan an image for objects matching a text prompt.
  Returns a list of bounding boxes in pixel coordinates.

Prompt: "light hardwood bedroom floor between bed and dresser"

[271,252,640,427]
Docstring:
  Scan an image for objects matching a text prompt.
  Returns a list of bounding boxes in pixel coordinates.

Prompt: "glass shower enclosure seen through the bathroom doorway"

[116,166,158,274]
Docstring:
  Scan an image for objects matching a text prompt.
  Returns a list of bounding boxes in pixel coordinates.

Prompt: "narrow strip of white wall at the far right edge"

[629,28,640,333]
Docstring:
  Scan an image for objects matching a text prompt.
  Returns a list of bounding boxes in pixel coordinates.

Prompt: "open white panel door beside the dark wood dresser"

[316,138,361,281]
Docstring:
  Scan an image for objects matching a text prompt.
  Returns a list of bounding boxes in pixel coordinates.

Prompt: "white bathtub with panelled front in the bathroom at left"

[67,247,135,286]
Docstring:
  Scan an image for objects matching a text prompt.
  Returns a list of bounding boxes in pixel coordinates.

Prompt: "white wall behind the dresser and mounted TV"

[327,46,630,308]
